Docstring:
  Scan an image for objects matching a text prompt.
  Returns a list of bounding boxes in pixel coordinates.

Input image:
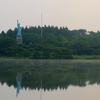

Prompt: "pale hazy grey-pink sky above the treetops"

[0,0,100,32]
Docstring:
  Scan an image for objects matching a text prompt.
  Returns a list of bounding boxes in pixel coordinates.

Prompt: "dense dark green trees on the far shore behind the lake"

[0,25,100,59]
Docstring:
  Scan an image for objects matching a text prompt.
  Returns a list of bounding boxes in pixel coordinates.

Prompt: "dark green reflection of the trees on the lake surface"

[0,60,100,91]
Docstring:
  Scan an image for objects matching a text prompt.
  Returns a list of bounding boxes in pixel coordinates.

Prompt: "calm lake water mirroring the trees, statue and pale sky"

[0,60,100,100]
